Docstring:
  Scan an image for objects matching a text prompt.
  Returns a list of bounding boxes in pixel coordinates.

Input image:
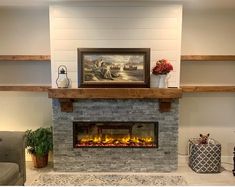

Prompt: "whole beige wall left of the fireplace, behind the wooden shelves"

[0,7,52,131]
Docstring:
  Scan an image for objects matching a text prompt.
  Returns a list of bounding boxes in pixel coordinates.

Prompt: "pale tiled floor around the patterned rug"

[25,160,235,186]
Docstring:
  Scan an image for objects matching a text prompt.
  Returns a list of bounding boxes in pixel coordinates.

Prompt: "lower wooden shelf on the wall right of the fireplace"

[181,86,235,93]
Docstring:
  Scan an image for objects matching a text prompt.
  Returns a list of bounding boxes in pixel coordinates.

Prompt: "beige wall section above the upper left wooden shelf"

[0,7,50,55]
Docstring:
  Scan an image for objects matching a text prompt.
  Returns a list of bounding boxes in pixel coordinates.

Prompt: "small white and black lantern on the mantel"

[56,65,70,88]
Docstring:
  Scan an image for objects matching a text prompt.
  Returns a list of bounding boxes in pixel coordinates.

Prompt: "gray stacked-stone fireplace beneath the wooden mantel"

[53,99,179,172]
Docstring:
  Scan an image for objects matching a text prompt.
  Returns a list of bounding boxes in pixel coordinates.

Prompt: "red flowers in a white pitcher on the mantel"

[152,59,173,88]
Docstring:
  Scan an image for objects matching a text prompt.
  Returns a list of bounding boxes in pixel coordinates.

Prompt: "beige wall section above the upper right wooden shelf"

[182,9,235,55]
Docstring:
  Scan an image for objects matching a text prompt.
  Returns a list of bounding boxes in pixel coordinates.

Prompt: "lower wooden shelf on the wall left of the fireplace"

[0,85,51,92]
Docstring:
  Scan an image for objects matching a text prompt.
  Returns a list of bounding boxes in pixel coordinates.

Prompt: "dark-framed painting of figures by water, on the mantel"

[78,48,150,88]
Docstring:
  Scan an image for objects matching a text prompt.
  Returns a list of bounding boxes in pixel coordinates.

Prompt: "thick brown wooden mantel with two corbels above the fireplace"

[48,88,182,112]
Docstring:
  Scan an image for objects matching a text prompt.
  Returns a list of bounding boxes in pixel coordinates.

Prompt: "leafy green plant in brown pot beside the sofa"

[26,127,53,168]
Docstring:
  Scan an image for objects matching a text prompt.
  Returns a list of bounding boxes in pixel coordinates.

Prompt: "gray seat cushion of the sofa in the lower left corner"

[0,162,19,186]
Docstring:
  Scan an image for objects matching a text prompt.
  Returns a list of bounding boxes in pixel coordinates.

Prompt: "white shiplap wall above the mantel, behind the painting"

[50,2,182,88]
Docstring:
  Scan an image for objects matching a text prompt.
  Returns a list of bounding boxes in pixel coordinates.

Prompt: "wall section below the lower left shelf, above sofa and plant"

[0,91,52,131]
